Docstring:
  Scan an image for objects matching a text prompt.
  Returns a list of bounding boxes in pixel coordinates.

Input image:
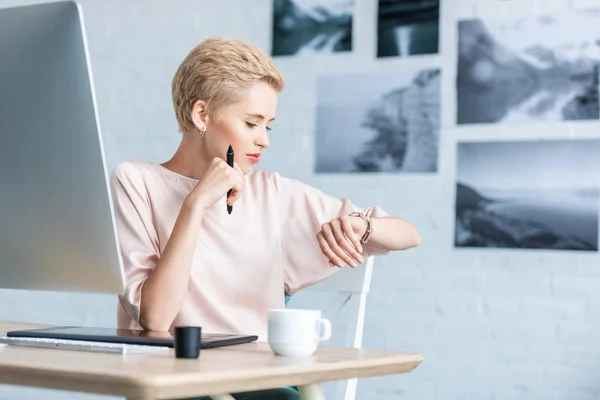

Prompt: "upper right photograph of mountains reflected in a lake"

[456,10,600,124]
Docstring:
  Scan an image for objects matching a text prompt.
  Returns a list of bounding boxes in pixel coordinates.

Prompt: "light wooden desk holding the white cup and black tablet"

[0,322,422,400]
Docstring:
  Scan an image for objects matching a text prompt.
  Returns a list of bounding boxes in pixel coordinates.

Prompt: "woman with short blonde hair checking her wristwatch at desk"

[112,38,419,399]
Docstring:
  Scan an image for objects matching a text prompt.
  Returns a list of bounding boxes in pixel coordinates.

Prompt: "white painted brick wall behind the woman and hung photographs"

[0,0,600,400]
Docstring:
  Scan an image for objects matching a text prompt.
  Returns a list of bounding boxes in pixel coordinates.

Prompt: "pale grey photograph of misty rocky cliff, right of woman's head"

[315,69,440,173]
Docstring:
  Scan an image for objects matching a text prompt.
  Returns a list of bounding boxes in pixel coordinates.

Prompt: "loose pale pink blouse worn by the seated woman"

[111,162,387,339]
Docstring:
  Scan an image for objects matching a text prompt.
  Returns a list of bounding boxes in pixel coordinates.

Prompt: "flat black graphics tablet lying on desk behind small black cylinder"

[6,326,258,349]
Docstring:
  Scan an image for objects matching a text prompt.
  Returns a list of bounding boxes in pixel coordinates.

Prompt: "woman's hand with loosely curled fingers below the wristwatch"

[317,216,367,268]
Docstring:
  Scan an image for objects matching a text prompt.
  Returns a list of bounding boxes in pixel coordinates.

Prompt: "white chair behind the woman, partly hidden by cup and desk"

[288,257,373,400]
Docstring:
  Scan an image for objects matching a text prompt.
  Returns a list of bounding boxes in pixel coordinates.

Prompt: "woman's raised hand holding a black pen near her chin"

[187,157,246,211]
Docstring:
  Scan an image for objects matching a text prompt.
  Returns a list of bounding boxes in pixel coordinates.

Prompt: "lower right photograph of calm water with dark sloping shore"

[455,139,600,251]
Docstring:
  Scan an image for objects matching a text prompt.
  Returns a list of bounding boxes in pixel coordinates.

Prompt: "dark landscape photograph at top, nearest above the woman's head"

[271,0,355,56]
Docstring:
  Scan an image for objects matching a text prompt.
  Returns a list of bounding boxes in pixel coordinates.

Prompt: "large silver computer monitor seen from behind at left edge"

[0,1,124,294]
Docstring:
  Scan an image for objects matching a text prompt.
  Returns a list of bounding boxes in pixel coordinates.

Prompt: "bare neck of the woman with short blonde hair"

[161,133,211,180]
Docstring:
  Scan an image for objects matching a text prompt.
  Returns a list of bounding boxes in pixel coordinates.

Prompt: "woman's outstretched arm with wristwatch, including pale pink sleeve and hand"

[273,174,420,294]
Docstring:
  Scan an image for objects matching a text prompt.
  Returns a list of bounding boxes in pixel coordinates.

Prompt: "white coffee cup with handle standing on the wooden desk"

[268,309,331,357]
